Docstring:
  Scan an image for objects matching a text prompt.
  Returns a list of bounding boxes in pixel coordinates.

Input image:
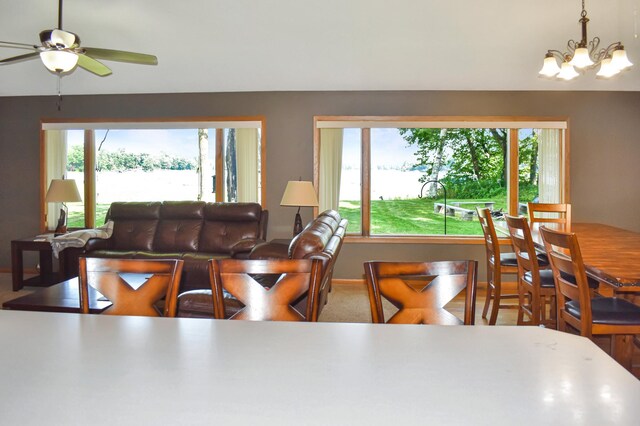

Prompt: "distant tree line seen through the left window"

[67,145,196,172]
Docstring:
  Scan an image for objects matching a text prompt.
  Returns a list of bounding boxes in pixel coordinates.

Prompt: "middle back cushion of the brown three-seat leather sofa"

[153,201,206,252]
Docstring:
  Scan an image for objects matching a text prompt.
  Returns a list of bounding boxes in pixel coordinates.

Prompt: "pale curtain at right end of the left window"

[236,129,260,203]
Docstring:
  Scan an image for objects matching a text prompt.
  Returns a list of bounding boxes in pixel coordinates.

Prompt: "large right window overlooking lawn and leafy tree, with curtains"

[314,117,568,237]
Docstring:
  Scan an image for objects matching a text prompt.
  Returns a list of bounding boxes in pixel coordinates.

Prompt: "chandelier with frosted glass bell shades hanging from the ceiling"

[539,0,633,81]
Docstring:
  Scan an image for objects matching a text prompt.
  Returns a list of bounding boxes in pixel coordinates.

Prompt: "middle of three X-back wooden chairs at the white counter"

[209,259,323,321]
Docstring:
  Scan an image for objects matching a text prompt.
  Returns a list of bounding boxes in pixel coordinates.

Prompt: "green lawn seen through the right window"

[339,197,506,235]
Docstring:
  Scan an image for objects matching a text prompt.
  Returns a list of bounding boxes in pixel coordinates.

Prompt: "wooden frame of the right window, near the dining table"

[313,115,571,244]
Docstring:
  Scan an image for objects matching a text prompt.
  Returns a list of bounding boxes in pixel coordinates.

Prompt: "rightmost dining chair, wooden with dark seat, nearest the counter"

[540,226,640,370]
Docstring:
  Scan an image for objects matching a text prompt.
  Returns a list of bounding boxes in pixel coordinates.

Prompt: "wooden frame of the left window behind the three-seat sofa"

[40,115,267,232]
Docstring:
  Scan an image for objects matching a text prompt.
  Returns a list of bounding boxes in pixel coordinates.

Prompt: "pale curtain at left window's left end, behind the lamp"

[44,130,67,230]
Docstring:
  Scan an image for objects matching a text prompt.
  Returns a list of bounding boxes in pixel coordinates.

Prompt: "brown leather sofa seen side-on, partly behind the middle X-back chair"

[178,210,348,318]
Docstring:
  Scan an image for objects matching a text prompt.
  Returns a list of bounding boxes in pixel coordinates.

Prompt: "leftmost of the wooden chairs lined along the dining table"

[476,207,519,325]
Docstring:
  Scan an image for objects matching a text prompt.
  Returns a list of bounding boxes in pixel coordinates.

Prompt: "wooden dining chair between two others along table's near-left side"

[505,215,556,329]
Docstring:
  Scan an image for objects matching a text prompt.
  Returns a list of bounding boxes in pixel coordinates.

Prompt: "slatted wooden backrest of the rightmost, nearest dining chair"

[540,226,592,330]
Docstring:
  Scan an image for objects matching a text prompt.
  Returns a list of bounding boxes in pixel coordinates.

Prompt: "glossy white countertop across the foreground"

[0,311,640,425]
